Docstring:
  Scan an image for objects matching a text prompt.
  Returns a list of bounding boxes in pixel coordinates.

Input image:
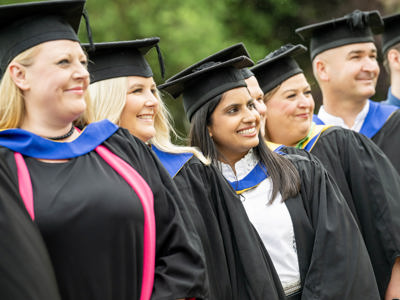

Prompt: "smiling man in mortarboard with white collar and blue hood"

[296,11,400,174]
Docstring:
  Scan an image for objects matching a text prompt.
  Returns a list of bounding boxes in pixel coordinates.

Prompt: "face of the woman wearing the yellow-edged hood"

[265,74,314,146]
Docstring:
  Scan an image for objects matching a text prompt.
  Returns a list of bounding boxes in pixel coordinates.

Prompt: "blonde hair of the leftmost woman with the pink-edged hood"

[0,45,40,129]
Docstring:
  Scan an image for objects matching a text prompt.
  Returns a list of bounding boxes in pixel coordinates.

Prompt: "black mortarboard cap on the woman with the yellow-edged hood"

[250,44,307,94]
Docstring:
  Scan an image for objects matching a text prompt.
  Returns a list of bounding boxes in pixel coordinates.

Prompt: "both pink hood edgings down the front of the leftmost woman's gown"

[14,146,156,300]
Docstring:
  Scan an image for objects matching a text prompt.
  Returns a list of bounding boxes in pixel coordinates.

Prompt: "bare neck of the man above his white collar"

[322,90,368,128]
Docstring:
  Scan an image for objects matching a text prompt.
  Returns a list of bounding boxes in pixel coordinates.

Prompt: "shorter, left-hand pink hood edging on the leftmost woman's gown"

[14,152,35,221]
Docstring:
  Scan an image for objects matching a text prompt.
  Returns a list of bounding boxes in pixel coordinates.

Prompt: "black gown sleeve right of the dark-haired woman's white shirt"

[285,151,380,300]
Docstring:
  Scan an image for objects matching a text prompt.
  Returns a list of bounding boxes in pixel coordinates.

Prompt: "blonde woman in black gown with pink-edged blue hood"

[0,0,207,300]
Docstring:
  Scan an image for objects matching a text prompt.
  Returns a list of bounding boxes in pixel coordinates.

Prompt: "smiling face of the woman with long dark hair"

[208,87,260,163]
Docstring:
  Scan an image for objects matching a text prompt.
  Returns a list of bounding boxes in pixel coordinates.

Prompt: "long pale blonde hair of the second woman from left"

[85,77,210,165]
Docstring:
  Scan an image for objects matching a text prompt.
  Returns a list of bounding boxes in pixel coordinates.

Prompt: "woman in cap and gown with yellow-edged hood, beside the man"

[251,44,400,299]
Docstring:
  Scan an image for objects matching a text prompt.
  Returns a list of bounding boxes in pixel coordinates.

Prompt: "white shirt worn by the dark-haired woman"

[220,150,300,292]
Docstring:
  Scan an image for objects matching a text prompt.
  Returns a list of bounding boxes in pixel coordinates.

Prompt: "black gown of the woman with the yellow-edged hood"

[281,126,400,298]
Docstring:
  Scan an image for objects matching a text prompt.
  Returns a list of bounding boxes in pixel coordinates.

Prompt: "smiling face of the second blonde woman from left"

[119,76,159,142]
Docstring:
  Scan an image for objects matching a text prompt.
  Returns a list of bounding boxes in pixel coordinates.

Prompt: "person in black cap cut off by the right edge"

[382,14,400,107]
